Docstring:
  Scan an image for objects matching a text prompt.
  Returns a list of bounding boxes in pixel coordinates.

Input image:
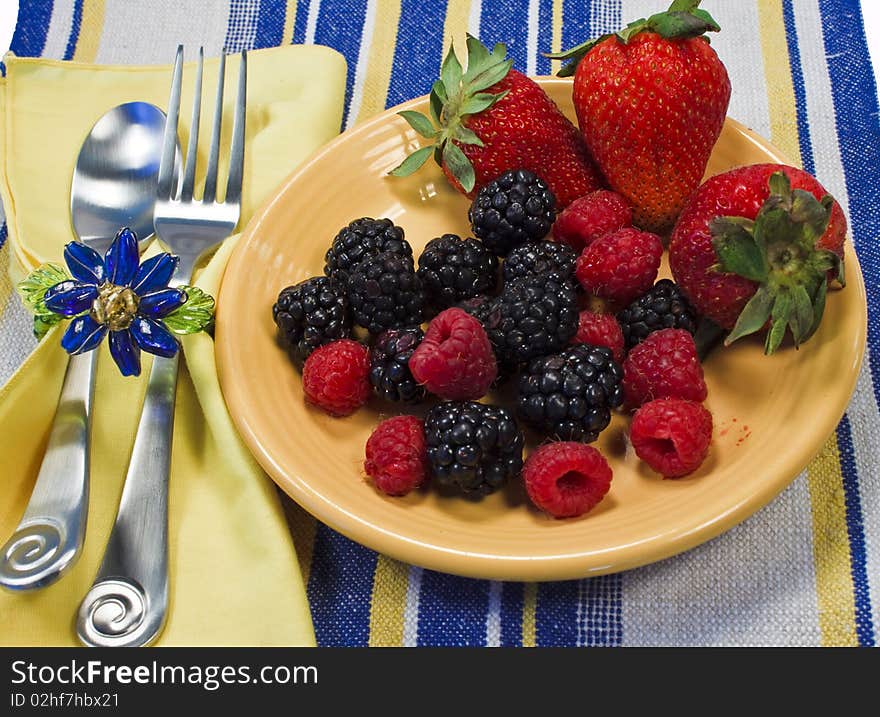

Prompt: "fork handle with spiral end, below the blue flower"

[76,354,179,647]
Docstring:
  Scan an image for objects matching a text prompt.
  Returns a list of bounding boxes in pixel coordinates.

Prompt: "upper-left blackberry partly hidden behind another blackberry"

[324,217,412,287]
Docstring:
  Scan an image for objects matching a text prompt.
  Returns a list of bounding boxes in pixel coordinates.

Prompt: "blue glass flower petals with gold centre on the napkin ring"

[42,228,187,376]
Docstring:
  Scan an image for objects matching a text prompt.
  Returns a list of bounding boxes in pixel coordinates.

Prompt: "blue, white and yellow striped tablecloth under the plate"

[0,0,880,646]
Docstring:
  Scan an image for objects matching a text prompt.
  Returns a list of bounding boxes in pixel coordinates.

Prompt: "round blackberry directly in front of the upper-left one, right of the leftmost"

[348,251,425,334]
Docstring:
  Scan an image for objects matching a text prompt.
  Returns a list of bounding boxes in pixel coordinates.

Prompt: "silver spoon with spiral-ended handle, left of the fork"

[0,102,179,590]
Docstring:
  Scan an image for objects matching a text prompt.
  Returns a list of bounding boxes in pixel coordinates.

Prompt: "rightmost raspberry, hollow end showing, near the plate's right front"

[630,398,712,478]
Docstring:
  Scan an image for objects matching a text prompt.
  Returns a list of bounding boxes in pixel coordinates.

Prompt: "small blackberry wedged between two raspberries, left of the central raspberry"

[370,326,426,403]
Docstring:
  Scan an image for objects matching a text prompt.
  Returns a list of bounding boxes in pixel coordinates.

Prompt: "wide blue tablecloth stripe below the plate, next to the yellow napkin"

[308,523,376,647]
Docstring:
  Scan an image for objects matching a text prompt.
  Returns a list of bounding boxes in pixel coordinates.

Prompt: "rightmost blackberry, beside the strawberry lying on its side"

[617,279,697,351]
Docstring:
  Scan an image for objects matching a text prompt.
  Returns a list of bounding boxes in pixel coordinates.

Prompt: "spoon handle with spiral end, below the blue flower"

[0,351,97,590]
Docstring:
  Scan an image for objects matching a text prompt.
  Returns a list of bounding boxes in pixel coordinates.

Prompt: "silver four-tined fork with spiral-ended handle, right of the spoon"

[76,45,247,647]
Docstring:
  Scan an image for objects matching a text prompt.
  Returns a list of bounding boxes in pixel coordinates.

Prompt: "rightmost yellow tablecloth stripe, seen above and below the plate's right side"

[758,0,858,646]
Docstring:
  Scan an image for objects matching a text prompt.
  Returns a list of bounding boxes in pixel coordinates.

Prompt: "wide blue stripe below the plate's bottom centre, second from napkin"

[418,570,489,647]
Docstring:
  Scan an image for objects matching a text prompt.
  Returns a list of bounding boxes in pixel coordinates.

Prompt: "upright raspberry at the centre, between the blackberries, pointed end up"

[409,307,498,401]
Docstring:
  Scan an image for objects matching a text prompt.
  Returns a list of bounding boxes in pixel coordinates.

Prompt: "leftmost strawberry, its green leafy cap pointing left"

[391,36,600,208]
